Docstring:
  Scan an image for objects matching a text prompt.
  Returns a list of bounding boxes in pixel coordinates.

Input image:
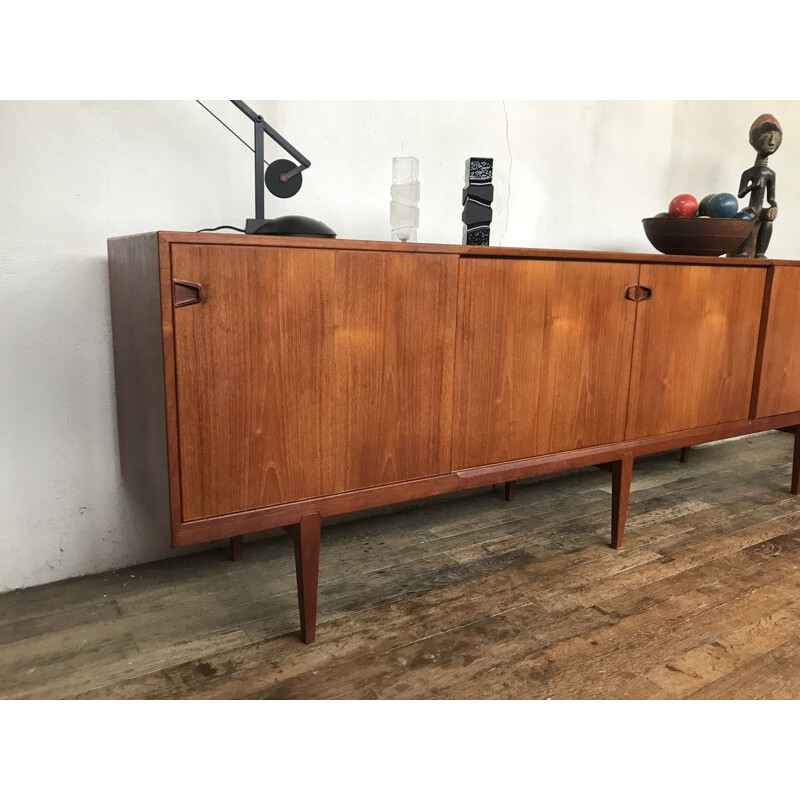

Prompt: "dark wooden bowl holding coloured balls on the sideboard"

[642,217,755,256]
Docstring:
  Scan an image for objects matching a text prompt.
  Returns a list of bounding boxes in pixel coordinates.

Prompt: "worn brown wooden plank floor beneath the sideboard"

[0,432,800,698]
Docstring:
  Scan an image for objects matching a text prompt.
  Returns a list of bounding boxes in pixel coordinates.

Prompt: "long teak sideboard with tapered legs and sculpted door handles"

[108,232,800,642]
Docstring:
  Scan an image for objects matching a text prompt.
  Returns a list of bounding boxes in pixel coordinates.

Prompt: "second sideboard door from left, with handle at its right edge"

[453,258,638,469]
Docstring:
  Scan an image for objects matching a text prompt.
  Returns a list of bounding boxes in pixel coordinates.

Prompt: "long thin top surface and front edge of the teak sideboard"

[109,231,800,269]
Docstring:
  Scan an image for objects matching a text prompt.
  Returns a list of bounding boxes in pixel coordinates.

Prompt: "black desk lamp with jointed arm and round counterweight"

[206,100,336,239]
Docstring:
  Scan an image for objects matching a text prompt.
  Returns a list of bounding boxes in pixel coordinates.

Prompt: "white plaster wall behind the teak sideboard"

[0,100,800,591]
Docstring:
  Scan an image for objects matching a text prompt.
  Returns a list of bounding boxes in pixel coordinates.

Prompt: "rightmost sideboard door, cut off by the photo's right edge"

[755,267,800,417]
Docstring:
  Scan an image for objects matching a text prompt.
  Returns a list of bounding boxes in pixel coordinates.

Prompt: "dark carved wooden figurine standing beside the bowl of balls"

[738,114,783,258]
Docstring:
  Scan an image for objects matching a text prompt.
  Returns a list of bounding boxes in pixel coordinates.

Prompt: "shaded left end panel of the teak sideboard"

[108,234,169,530]
